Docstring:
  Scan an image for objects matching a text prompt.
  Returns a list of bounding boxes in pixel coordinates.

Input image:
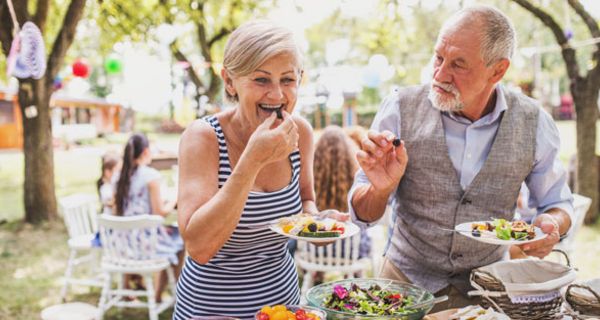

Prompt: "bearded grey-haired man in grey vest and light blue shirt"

[349,6,573,308]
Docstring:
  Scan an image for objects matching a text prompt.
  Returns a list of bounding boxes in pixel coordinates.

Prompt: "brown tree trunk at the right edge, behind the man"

[571,81,599,224]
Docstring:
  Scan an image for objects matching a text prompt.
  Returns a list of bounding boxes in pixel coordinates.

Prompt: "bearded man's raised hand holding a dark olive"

[356,131,408,194]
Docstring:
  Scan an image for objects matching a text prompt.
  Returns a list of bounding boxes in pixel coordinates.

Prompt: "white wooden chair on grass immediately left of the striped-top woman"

[98,214,175,320]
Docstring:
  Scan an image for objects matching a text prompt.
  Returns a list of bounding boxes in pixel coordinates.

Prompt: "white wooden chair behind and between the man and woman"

[294,232,371,297]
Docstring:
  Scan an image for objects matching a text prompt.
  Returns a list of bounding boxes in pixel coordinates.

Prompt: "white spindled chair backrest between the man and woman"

[296,232,361,272]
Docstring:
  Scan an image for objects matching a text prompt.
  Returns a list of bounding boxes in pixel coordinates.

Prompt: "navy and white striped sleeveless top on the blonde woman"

[173,116,302,320]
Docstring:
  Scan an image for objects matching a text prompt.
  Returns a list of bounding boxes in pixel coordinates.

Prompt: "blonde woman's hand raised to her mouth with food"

[244,111,299,165]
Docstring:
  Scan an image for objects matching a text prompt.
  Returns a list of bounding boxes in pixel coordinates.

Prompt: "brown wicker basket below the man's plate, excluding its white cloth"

[471,250,571,320]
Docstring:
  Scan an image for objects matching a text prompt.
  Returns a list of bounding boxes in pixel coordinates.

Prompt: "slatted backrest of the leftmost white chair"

[58,193,99,238]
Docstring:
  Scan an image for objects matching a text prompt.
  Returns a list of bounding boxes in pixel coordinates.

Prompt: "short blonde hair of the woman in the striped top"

[223,20,302,102]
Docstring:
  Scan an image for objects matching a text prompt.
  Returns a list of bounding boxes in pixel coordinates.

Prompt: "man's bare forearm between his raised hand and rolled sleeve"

[352,184,391,222]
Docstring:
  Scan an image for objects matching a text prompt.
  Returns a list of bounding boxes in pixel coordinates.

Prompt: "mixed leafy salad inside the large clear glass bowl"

[324,283,417,315]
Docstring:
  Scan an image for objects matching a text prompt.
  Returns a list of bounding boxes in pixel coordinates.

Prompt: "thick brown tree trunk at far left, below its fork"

[19,78,58,224]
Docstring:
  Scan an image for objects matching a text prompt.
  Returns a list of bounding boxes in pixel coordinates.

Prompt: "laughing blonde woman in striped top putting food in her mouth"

[174,21,330,319]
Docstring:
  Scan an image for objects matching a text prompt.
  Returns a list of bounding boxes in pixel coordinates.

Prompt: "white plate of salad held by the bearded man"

[454,219,548,245]
